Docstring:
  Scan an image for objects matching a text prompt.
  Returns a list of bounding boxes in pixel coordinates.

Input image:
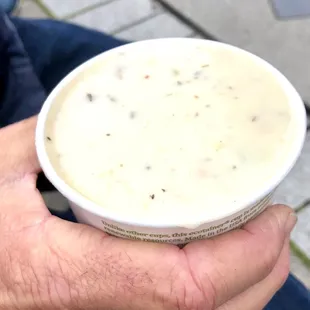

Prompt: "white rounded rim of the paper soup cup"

[35,38,307,228]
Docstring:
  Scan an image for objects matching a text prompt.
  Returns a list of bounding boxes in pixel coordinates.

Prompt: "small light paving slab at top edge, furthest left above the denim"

[41,0,111,18]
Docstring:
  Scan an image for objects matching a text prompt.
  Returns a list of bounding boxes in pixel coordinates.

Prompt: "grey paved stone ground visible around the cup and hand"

[15,0,310,288]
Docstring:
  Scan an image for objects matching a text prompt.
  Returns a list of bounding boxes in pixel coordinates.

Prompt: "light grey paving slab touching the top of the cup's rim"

[115,13,193,41]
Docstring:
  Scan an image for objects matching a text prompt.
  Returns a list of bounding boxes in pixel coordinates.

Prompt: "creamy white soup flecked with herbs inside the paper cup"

[46,41,293,222]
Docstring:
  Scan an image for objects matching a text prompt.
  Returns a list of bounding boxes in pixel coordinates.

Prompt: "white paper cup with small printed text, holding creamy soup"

[36,39,306,245]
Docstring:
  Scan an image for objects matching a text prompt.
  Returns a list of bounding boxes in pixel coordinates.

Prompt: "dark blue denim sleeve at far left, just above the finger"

[0,12,46,127]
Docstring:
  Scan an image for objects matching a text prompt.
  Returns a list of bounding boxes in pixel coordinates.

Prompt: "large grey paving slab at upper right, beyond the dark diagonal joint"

[162,0,310,107]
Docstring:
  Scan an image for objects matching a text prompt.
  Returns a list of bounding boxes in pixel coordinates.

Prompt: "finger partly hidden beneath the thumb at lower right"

[217,239,290,310]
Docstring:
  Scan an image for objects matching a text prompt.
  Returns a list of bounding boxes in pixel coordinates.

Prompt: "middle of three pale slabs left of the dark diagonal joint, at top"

[70,0,162,33]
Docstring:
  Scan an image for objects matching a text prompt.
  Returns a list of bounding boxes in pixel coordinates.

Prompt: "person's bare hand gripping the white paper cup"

[0,118,296,310]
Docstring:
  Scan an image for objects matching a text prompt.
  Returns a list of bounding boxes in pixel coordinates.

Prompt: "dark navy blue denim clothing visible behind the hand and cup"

[0,13,310,310]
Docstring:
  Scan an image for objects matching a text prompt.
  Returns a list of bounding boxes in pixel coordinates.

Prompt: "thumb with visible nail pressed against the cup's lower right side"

[184,205,296,307]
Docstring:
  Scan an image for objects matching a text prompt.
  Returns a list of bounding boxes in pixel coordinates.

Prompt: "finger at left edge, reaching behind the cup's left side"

[0,117,40,184]
